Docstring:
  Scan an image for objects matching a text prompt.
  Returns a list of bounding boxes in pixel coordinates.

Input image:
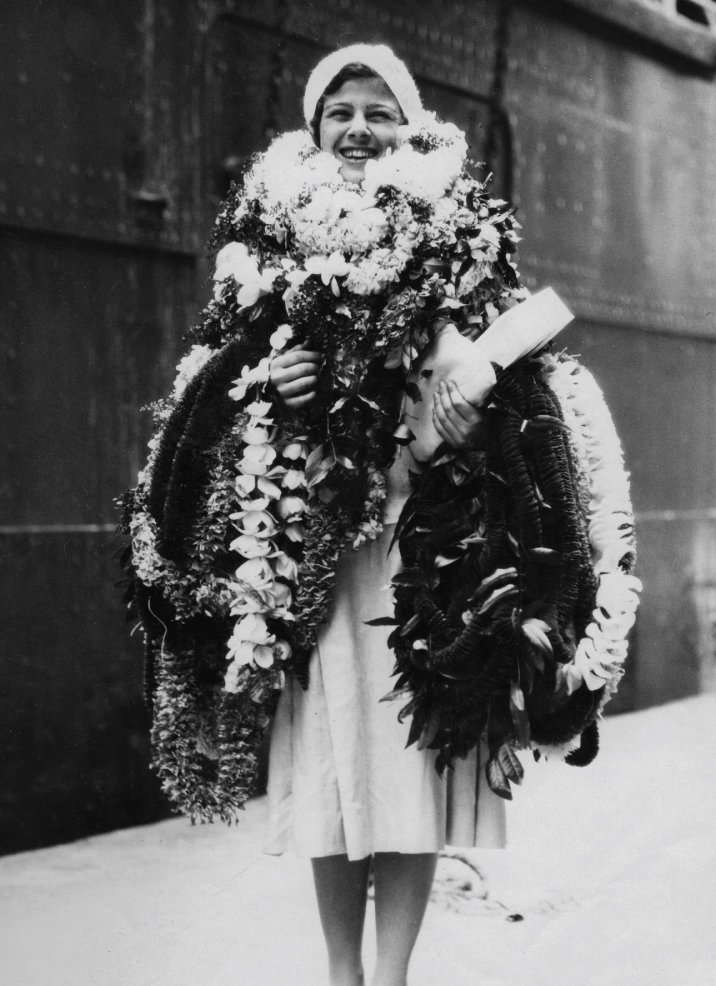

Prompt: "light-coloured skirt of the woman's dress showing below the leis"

[264,446,505,859]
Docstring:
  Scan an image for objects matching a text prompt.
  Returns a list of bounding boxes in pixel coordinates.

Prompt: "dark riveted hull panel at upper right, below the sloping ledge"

[506,5,716,336]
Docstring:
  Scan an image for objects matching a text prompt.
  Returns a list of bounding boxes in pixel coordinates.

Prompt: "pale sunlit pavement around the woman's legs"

[0,695,716,986]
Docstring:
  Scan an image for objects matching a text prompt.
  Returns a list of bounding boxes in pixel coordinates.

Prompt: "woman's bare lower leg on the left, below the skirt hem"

[311,855,370,986]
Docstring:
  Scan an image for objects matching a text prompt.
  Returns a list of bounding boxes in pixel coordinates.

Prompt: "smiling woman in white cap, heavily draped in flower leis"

[127,38,637,986]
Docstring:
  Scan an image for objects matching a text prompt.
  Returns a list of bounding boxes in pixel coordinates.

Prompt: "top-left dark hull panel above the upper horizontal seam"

[0,0,201,252]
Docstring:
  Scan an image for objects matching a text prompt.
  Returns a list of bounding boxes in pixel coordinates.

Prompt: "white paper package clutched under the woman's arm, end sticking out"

[403,288,574,462]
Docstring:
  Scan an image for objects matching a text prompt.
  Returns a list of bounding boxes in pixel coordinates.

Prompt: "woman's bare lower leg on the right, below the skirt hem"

[373,852,438,986]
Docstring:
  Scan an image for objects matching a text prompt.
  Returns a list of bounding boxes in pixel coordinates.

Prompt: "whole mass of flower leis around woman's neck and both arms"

[117,115,639,821]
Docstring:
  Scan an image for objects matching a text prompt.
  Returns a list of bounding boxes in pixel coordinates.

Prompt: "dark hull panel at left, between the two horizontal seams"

[0,230,195,524]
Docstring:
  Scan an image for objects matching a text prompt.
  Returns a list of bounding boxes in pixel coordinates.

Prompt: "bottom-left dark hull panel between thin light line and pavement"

[0,534,167,853]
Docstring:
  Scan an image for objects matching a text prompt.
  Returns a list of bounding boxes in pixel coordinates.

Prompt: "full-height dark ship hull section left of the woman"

[0,0,203,851]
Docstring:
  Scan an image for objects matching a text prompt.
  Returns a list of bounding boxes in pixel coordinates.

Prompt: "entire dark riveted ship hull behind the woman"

[0,0,716,851]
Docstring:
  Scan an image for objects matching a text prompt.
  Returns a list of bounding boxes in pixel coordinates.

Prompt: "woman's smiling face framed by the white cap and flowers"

[319,78,403,181]
